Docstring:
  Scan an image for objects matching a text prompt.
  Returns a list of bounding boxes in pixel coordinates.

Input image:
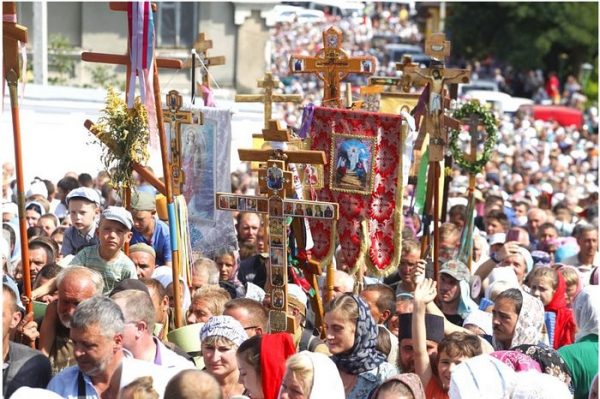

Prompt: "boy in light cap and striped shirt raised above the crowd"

[70,206,137,294]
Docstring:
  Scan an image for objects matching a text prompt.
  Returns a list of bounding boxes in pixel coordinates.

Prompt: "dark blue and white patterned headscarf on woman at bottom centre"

[331,294,385,374]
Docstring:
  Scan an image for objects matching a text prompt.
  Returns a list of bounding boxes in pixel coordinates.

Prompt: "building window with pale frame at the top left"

[155,1,198,48]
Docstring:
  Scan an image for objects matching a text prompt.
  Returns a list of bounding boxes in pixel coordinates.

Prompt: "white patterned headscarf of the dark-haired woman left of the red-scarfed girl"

[492,291,544,350]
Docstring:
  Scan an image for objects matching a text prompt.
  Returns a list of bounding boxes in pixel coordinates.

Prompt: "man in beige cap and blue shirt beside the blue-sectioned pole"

[131,192,172,266]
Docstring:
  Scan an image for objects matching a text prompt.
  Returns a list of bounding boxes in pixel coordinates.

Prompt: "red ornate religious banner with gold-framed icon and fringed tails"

[309,107,406,275]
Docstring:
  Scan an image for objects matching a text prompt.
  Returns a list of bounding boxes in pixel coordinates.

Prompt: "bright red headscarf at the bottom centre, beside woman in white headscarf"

[260,333,296,399]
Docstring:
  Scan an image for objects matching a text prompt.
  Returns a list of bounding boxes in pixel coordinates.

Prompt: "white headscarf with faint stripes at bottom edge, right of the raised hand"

[448,355,517,399]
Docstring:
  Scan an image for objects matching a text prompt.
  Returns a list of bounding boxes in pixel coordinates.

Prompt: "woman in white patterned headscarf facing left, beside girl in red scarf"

[492,288,544,350]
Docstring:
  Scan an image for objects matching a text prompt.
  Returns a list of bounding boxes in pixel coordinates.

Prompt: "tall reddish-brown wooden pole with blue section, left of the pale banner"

[153,62,183,328]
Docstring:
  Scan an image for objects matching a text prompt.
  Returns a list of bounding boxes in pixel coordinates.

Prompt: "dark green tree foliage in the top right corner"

[446,2,598,73]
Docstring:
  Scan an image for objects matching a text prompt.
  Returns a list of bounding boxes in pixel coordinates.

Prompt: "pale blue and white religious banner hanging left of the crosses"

[168,104,237,257]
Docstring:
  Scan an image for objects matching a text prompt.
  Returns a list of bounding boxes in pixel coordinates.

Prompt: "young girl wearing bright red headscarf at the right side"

[529,267,576,349]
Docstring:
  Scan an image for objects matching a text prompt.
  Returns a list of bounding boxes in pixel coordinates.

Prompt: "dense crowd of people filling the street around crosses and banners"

[0,3,600,399]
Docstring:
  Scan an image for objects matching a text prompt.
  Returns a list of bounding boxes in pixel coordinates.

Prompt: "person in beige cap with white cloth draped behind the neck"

[437,260,477,326]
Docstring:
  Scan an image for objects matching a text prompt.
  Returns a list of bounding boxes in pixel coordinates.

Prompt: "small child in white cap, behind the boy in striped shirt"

[60,187,100,256]
